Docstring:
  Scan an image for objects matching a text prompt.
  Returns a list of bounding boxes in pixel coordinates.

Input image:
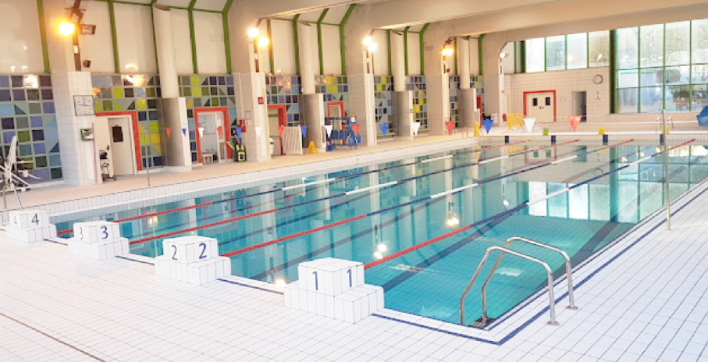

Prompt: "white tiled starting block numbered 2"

[155,236,231,285]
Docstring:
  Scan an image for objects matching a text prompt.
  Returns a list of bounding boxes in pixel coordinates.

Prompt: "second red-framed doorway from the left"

[196,112,228,165]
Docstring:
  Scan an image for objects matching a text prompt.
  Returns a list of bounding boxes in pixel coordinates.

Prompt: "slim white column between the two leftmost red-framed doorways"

[153,5,179,98]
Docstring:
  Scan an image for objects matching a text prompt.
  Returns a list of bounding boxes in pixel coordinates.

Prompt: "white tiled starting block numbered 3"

[69,221,130,260]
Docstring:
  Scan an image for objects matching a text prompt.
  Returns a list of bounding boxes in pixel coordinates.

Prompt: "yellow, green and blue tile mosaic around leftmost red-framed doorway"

[91,74,162,169]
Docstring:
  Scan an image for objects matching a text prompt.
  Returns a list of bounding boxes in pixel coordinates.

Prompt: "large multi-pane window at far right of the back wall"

[612,20,708,113]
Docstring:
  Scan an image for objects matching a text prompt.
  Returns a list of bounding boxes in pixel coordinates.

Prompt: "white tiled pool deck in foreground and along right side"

[0,175,708,362]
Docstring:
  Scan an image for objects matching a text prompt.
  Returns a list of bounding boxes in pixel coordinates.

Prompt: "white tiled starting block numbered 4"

[5,210,57,243]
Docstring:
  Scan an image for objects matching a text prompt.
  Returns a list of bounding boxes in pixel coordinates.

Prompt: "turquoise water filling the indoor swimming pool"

[57,142,708,323]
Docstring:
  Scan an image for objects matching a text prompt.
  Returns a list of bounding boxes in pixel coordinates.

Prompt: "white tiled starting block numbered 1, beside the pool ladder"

[285,258,384,323]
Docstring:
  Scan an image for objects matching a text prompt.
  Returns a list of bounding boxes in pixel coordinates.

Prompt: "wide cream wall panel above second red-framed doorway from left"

[194,11,226,74]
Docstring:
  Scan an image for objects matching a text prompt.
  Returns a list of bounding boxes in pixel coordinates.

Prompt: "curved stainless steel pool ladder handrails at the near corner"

[460,236,578,328]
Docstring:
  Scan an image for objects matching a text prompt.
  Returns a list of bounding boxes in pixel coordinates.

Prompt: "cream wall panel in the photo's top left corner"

[0,0,44,74]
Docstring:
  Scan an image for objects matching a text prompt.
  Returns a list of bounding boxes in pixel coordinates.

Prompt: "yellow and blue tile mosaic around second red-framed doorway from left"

[179,75,237,162]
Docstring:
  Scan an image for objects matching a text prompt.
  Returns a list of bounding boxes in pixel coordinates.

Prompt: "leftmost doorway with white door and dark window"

[94,115,138,176]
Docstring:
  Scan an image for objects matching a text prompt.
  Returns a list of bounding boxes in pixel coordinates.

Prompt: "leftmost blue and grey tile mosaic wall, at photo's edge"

[0,75,62,183]
